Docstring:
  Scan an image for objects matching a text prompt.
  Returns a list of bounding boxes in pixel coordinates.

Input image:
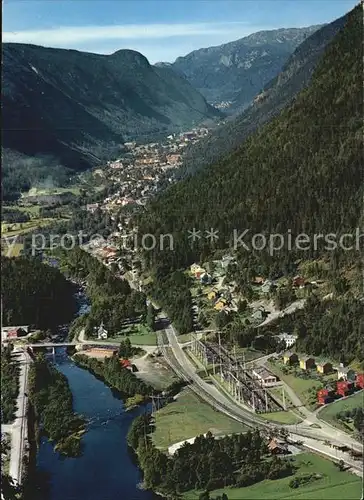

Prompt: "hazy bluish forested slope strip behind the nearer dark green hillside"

[180,11,347,177]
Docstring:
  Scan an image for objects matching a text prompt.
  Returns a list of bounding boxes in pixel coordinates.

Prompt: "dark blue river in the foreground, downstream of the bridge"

[37,349,161,500]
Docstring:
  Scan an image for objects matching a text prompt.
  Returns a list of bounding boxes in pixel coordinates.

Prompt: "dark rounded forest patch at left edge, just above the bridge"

[1,257,77,329]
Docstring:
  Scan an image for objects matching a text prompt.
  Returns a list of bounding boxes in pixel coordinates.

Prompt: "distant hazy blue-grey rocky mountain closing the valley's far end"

[159,26,320,111]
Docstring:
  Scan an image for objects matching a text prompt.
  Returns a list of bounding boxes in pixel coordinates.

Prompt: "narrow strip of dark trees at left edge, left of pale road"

[1,345,19,424]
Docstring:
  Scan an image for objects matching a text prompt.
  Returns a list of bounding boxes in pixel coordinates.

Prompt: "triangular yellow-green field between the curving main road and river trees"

[152,389,247,449]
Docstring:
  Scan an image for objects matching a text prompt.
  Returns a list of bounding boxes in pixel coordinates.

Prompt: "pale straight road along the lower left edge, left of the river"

[1,350,31,484]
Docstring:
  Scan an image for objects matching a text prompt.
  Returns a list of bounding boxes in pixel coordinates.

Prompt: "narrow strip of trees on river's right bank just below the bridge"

[74,354,153,397]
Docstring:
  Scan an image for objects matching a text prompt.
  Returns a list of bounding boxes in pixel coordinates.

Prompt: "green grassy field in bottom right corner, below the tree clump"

[183,453,361,500]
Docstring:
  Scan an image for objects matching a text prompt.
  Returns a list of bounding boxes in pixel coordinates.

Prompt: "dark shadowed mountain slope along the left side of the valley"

[2,44,219,174]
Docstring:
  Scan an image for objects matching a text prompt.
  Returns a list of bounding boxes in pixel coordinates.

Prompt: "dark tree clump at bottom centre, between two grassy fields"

[128,415,294,498]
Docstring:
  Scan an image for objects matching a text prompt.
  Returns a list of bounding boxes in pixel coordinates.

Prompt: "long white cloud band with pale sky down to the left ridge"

[3,21,274,63]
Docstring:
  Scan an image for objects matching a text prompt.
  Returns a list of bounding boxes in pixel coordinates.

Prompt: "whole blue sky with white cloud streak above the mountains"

[3,0,358,63]
